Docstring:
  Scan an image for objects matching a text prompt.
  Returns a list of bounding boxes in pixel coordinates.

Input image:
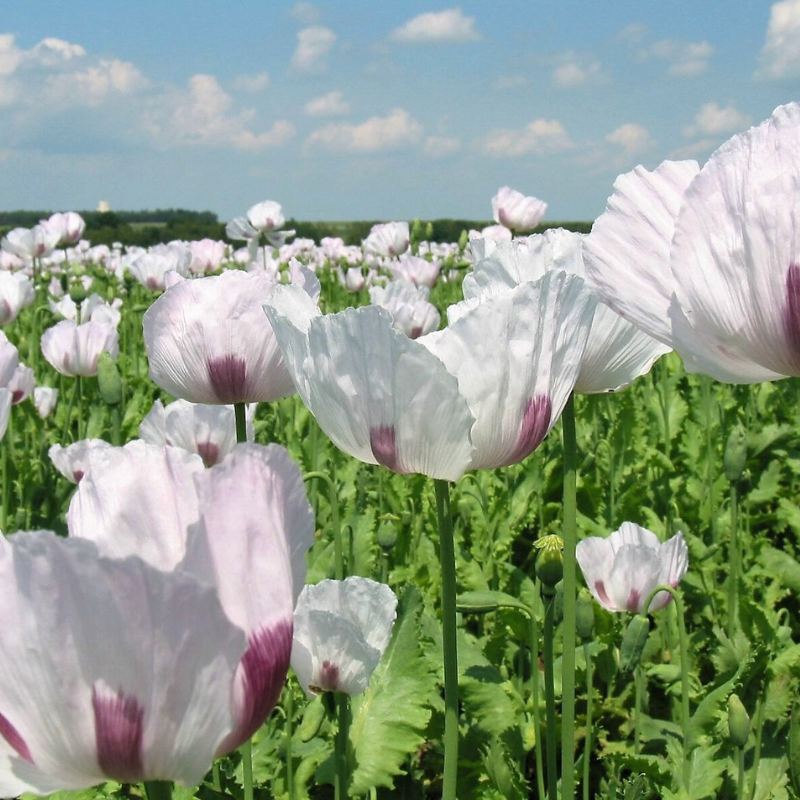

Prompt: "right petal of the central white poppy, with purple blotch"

[418,271,595,469]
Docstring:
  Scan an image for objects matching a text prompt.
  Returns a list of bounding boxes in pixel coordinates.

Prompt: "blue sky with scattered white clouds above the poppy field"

[0,0,800,221]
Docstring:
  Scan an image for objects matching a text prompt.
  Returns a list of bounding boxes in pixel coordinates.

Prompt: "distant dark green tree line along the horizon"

[0,208,592,247]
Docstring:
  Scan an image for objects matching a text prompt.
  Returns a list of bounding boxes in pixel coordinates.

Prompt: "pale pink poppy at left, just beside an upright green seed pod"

[41,319,119,378]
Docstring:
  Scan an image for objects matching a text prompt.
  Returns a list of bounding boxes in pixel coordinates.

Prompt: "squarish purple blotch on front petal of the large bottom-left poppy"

[92,687,144,783]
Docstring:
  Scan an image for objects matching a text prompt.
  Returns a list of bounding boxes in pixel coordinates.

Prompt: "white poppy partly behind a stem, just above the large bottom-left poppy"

[139,400,256,467]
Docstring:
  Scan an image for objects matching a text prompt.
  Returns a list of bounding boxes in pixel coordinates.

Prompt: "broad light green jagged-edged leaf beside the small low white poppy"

[350,586,435,796]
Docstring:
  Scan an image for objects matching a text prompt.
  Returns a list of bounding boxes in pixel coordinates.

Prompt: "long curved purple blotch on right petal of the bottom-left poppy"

[217,620,293,755]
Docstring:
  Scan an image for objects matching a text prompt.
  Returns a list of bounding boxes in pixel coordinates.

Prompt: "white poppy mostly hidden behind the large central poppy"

[463,228,669,394]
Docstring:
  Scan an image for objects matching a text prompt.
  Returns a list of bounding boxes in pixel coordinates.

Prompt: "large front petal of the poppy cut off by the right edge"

[670,103,800,383]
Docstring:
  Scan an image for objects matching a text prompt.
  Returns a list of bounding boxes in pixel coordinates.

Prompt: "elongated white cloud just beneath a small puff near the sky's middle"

[306,108,422,153]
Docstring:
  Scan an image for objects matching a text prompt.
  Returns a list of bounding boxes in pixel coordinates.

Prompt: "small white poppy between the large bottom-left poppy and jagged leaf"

[292,577,397,697]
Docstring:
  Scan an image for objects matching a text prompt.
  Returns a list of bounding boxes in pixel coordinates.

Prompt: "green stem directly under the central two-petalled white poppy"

[433,480,458,800]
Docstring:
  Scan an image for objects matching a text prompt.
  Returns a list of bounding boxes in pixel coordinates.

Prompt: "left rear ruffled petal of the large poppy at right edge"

[584,161,699,347]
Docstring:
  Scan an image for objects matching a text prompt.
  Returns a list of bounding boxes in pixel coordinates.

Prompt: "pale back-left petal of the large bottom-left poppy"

[67,440,204,570]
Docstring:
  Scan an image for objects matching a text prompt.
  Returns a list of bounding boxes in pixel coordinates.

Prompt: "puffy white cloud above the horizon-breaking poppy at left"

[144,75,295,151]
